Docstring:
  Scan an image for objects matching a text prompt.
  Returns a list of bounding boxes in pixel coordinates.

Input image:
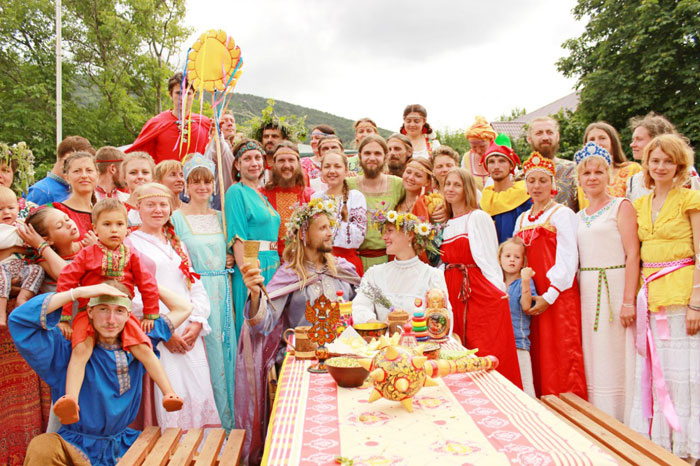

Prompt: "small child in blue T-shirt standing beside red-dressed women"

[498,237,537,398]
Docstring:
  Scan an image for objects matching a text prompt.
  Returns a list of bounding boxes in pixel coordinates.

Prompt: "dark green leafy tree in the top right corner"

[557,0,700,166]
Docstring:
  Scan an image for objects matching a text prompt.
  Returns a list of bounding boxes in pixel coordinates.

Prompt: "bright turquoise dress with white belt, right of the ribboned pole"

[225,183,280,337]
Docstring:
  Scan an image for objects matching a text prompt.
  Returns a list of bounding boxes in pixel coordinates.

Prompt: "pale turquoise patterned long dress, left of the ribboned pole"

[171,210,238,431]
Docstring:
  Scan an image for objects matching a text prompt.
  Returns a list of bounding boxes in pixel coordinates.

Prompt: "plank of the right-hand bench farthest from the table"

[559,393,688,466]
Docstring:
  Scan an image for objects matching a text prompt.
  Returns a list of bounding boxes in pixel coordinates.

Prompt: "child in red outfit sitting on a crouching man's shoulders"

[54,199,183,424]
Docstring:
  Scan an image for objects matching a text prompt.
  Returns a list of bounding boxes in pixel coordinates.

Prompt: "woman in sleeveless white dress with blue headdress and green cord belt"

[575,142,639,422]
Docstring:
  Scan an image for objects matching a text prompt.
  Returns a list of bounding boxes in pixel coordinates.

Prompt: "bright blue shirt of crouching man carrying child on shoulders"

[8,293,173,465]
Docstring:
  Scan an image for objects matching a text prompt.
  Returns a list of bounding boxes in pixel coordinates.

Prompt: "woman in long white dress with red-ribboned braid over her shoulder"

[127,183,221,429]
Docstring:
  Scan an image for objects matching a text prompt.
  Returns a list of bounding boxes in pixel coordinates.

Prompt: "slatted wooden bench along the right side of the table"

[541,393,687,466]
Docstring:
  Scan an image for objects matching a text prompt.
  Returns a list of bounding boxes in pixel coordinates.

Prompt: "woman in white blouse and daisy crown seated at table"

[352,210,453,333]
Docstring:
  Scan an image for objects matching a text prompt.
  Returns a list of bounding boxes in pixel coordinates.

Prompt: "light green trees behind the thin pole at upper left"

[0,0,190,167]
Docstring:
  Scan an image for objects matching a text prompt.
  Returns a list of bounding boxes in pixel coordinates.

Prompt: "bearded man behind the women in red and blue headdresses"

[527,117,578,212]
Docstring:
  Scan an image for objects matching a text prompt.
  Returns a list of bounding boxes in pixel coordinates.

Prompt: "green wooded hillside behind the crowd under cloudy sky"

[228,93,395,145]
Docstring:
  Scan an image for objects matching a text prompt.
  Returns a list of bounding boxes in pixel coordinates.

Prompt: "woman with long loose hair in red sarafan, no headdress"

[440,168,522,390]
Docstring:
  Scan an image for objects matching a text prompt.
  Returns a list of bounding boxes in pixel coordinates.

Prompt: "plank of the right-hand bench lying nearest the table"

[541,395,650,465]
